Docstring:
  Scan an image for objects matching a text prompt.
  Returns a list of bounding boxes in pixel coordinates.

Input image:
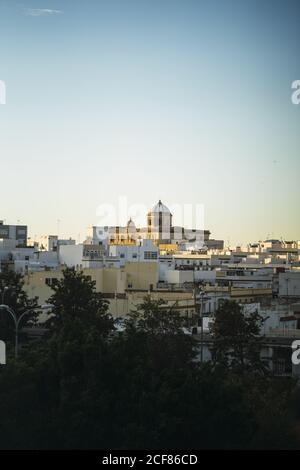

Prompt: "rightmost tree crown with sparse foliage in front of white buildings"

[211,300,267,373]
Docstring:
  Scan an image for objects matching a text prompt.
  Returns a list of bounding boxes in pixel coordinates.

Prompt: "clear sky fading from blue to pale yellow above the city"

[0,0,300,244]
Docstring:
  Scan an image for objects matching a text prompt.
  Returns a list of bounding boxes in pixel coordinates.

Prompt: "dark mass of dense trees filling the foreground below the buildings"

[0,270,299,449]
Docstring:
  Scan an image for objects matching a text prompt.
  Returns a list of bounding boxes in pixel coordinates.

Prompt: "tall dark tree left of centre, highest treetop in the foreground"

[39,269,114,448]
